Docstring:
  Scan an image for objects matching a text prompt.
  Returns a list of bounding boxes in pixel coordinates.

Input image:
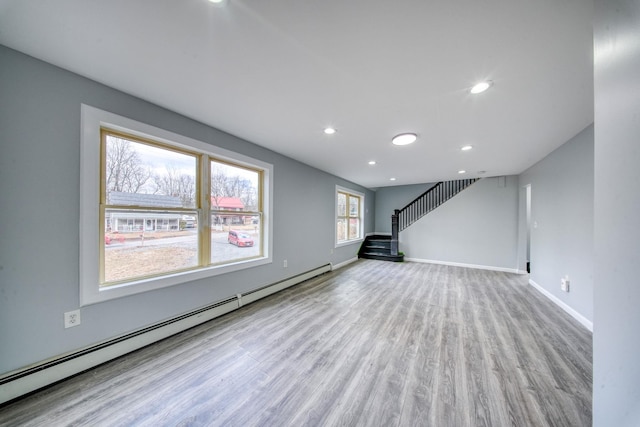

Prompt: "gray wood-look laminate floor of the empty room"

[0,260,592,427]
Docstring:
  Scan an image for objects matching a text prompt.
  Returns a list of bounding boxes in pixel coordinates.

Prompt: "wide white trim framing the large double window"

[79,104,273,306]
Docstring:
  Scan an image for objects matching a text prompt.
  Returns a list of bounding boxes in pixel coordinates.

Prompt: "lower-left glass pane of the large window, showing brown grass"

[103,209,198,286]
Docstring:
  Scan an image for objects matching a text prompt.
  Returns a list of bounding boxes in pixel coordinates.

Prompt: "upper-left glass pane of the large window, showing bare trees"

[105,135,197,208]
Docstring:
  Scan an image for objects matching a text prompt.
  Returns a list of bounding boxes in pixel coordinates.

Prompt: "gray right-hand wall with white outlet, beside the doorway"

[519,125,593,322]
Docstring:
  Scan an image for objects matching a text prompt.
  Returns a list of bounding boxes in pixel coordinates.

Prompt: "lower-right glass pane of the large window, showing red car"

[211,213,262,264]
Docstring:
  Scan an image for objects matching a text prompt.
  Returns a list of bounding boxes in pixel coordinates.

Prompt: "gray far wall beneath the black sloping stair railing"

[396,176,518,270]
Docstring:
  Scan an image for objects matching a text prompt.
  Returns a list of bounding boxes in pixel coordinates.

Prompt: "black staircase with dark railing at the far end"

[358,178,480,262]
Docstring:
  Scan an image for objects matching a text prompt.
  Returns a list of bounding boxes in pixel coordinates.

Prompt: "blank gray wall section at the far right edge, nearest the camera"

[593,0,640,427]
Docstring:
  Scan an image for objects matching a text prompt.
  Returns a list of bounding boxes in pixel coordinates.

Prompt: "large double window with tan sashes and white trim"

[80,105,272,305]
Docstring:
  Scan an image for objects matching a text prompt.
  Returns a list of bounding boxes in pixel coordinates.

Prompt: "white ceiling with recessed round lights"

[0,0,593,188]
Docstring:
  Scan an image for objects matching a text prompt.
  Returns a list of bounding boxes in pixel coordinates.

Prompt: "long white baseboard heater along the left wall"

[0,264,331,404]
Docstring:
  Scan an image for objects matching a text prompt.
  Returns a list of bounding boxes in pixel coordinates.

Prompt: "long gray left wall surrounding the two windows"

[0,46,375,374]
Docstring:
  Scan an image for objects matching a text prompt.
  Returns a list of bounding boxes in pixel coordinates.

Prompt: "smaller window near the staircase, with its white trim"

[336,187,364,246]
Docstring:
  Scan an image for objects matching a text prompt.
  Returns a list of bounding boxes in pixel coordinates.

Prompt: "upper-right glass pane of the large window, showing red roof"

[211,161,260,212]
